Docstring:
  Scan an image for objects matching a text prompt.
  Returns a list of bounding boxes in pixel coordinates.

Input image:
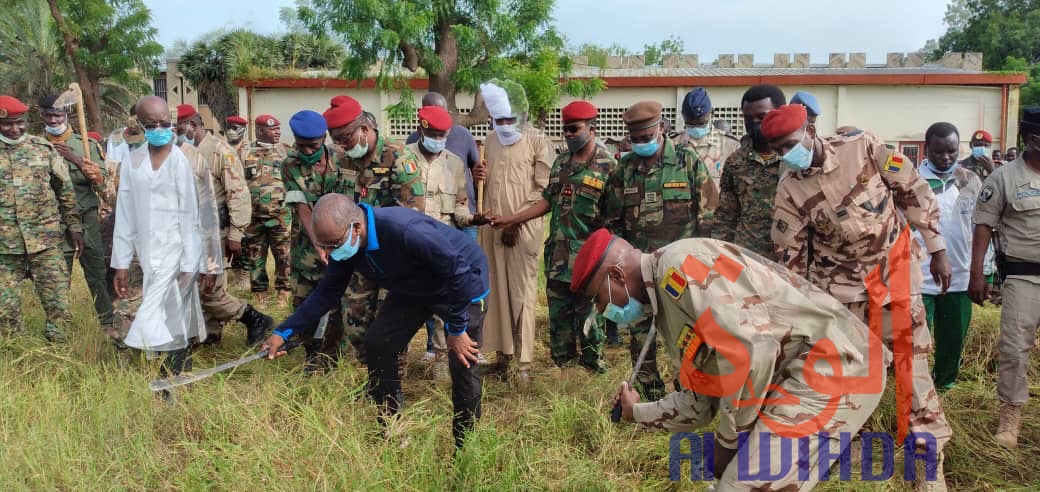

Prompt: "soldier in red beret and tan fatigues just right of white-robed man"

[177,104,274,345]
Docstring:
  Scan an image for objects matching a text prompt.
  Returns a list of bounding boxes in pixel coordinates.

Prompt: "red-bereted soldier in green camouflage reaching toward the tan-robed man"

[492,101,618,382]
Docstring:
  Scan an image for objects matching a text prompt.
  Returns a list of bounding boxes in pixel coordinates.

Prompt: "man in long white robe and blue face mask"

[111,97,206,374]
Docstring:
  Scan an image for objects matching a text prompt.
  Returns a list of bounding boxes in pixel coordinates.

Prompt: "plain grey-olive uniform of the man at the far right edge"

[972,154,1040,407]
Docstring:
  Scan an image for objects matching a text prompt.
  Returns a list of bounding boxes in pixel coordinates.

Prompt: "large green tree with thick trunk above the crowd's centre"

[298,0,596,126]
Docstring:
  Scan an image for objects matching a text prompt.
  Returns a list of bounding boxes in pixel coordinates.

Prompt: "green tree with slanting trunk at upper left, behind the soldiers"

[47,0,163,129]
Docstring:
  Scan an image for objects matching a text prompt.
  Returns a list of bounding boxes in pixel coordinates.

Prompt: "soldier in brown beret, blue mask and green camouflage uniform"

[608,101,718,397]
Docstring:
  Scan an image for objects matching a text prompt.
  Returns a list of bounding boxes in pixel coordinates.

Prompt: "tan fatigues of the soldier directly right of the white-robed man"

[196,135,252,340]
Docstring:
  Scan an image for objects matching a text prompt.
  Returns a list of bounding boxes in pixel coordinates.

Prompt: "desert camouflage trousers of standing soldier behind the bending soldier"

[844,294,953,450]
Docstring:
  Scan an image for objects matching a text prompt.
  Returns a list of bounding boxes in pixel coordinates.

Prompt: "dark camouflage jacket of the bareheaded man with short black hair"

[711,146,780,260]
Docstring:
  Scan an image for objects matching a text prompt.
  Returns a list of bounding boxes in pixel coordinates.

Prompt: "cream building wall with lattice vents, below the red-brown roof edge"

[238,85,1018,154]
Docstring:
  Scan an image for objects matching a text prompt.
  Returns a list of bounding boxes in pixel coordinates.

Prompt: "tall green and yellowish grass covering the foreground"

[0,263,1040,491]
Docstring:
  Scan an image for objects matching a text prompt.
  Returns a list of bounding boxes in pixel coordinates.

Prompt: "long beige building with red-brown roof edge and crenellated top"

[237,53,1025,161]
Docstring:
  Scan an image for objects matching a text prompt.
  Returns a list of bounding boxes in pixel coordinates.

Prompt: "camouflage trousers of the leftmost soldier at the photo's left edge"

[0,248,72,339]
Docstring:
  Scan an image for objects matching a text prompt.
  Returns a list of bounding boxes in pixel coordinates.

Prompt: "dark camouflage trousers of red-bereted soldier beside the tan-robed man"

[545,280,606,370]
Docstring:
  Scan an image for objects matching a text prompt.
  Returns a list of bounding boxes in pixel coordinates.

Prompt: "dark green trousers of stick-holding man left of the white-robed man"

[61,208,112,325]
